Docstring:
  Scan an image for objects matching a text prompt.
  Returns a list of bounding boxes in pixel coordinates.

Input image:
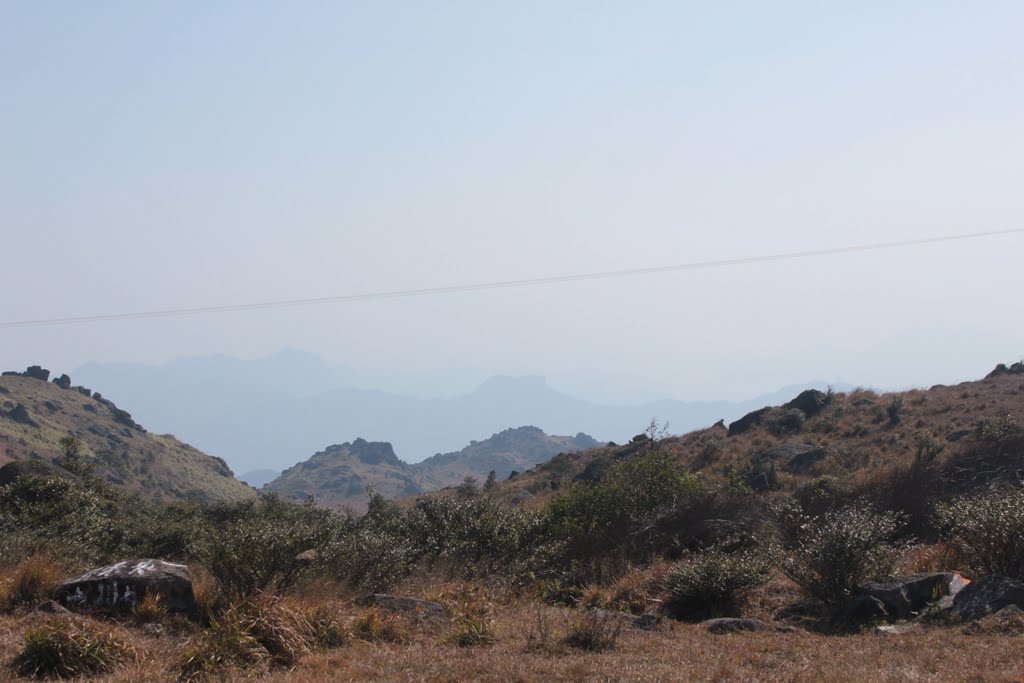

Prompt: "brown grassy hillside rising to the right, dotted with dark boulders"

[494,364,1024,506]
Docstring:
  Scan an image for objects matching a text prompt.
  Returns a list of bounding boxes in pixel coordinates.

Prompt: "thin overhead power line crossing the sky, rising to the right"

[0,228,1024,329]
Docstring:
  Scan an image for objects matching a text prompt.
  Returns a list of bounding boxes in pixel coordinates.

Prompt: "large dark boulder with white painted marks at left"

[53,559,196,613]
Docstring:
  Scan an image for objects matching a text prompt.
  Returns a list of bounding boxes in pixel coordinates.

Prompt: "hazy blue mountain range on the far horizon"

[74,351,846,472]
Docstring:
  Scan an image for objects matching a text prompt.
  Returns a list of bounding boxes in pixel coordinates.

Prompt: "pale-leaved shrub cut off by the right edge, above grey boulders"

[937,487,1024,581]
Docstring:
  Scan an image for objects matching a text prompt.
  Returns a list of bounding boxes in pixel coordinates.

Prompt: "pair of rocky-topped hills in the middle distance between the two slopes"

[263,427,601,512]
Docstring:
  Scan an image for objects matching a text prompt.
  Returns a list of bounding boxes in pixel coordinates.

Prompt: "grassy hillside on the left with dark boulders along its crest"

[0,371,254,502]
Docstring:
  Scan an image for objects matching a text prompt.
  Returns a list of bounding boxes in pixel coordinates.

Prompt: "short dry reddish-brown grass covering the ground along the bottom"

[0,591,1024,683]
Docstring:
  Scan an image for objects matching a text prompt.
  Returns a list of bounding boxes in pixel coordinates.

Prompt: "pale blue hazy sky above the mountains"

[0,0,1024,399]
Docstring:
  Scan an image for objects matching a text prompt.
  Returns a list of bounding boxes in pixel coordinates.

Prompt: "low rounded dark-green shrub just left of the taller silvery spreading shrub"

[664,544,772,620]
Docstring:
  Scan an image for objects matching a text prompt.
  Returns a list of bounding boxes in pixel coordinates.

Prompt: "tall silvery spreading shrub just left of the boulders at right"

[782,503,904,608]
